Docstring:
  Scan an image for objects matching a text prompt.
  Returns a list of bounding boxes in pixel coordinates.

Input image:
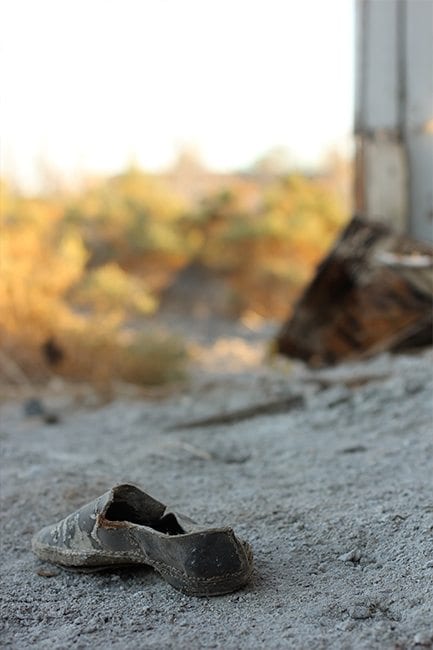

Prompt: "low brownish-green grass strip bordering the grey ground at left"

[0,319,188,399]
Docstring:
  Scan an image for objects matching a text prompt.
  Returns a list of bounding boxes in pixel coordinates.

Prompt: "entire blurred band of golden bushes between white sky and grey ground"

[0,159,348,388]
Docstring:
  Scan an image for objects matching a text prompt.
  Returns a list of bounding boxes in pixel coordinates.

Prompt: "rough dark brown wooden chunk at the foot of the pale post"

[276,217,433,366]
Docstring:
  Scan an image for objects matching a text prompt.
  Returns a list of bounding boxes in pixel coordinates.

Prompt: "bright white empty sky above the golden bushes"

[0,0,354,189]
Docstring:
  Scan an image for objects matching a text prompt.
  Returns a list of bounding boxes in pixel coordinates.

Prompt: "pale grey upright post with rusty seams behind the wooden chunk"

[355,0,433,240]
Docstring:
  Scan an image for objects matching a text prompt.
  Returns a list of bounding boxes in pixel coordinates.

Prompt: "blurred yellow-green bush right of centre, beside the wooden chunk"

[186,171,347,318]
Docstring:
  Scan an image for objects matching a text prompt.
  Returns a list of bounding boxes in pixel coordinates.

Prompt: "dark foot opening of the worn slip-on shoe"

[104,490,185,535]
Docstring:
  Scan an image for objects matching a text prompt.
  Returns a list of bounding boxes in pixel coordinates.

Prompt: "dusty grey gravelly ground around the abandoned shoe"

[0,324,433,650]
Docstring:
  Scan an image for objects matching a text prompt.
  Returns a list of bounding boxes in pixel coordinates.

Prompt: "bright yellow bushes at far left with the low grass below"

[0,185,186,396]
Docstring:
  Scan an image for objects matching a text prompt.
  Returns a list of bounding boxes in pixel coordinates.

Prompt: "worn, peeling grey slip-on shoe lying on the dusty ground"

[32,483,252,596]
